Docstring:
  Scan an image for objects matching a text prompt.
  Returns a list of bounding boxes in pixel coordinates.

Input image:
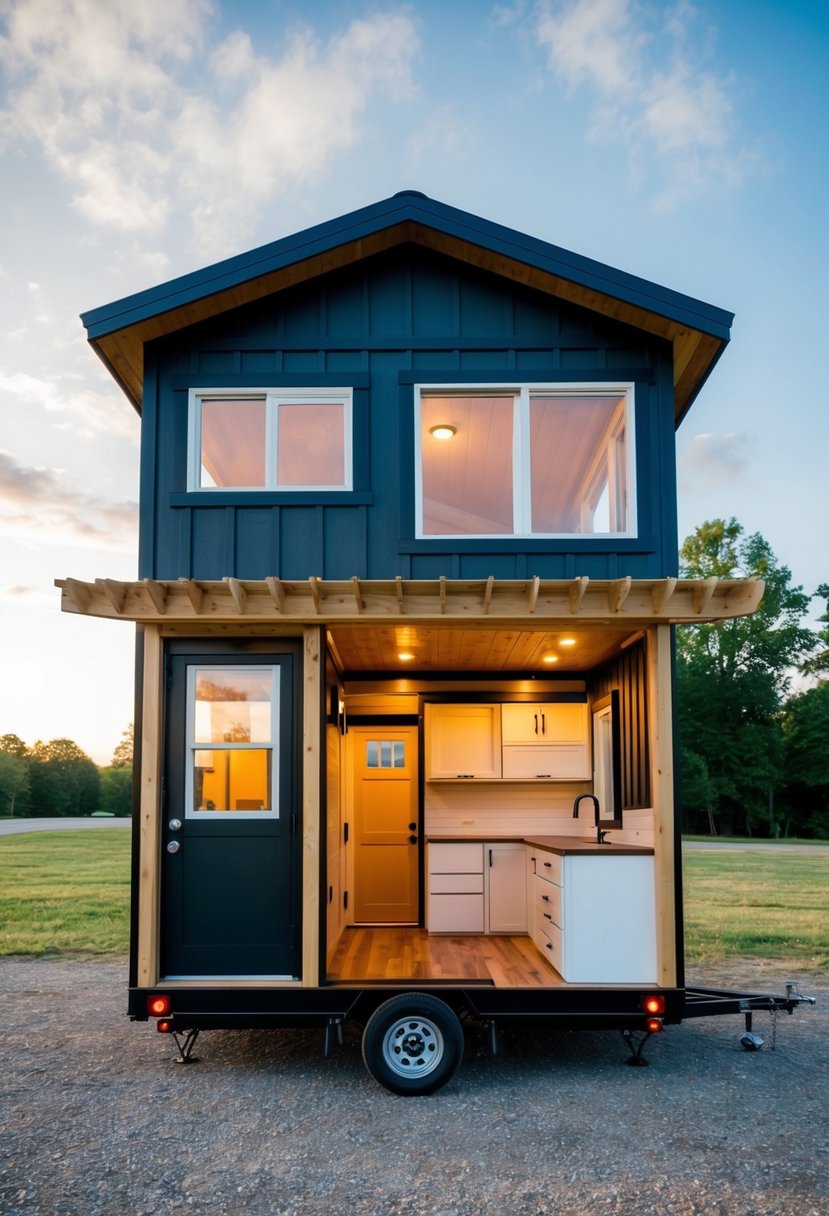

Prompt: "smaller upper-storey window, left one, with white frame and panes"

[188,388,353,490]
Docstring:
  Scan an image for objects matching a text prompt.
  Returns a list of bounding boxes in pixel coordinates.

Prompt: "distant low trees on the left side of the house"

[0,726,132,818]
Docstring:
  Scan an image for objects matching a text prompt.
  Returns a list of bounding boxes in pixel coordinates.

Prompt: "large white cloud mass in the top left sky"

[0,0,418,255]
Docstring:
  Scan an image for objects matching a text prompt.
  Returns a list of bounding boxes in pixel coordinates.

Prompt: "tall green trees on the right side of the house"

[677,518,829,838]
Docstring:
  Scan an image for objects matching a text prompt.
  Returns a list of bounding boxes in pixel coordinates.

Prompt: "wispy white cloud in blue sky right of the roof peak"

[534,0,758,209]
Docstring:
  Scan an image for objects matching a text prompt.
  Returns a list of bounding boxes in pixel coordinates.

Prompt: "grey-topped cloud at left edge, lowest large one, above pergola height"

[0,451,139,548]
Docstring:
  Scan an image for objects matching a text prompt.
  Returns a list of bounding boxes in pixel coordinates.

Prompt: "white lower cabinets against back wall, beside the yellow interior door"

[427,840,526,933]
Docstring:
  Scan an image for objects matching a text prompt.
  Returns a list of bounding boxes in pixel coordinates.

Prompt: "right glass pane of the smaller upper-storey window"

[276,401,345,486]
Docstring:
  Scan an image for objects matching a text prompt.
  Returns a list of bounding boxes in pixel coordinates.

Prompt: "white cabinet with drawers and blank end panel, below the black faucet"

[528,846,656,984]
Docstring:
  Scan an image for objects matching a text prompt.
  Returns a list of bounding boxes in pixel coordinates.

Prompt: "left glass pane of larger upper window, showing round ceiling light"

[421,393,515,536]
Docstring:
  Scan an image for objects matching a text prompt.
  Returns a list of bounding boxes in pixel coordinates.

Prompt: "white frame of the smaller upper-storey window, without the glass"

[187,388,354,494]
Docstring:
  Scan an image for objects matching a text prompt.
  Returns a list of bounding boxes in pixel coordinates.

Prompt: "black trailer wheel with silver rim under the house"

[362,992,463,1094]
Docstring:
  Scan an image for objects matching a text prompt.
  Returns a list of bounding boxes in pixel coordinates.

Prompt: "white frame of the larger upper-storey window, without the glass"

[415,381,638,541]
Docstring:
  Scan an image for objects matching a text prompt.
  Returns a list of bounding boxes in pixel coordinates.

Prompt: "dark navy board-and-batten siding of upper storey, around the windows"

[140,247,677,579]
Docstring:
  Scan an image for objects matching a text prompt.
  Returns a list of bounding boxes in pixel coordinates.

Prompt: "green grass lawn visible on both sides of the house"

[0,828,829,972]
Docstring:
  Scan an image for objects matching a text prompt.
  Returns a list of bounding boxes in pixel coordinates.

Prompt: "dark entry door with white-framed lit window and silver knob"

[162,652,300,979]
